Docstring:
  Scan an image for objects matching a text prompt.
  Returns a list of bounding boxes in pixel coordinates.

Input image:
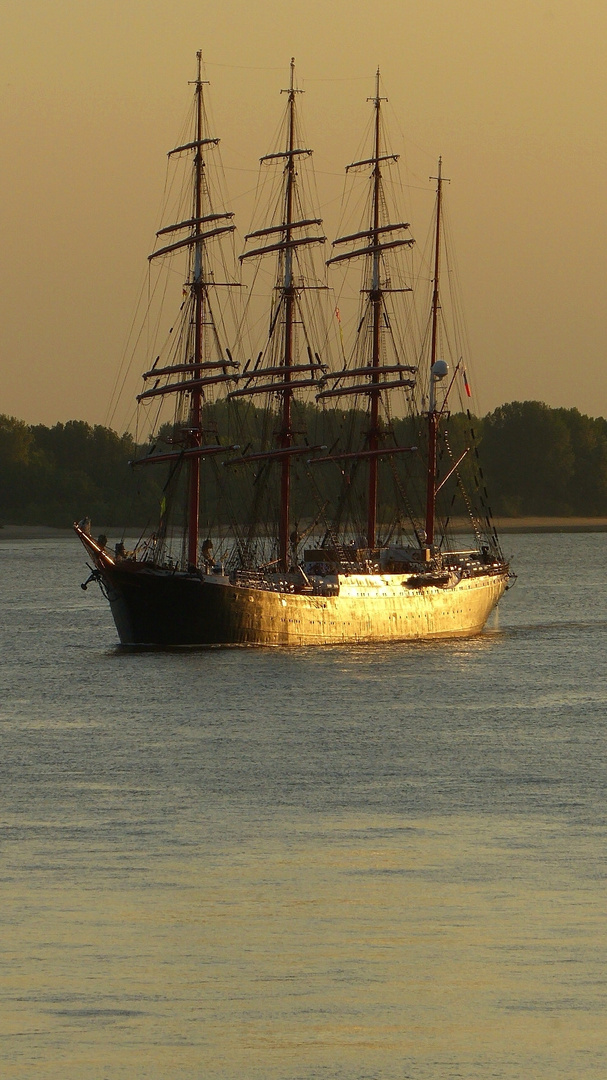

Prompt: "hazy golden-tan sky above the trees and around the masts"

[0,0,607,424]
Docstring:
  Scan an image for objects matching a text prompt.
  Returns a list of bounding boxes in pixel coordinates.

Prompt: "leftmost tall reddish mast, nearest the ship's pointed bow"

[188,50,204,566]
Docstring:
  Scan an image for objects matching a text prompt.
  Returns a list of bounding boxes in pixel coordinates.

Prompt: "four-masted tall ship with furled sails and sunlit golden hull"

[75,53,510,648]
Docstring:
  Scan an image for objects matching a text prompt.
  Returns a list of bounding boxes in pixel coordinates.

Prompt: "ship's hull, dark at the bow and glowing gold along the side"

[83,548,507,647]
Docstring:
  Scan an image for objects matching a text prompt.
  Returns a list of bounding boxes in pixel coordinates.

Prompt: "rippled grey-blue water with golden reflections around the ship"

[0,535,607,1080]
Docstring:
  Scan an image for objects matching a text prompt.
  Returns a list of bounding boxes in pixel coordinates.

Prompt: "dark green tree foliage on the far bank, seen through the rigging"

[0,402,607,527]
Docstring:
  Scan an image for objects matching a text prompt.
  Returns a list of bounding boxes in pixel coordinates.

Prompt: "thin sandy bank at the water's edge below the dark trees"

[0,517,607,541]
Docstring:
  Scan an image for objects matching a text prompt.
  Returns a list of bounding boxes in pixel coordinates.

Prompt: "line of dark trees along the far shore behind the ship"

[0,402,607,527]
